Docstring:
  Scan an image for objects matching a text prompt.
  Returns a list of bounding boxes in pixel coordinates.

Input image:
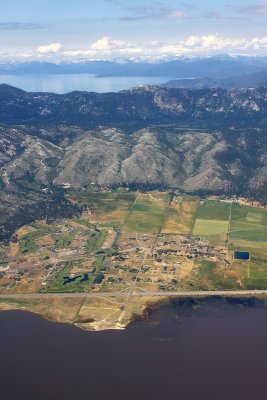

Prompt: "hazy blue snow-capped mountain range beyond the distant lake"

[0,56,267,80]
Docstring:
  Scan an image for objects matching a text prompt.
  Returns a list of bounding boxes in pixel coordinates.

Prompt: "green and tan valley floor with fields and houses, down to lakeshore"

[0,190,267,330]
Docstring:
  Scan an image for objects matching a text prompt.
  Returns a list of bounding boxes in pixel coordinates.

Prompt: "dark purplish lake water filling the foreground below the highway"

[0,300,267,400]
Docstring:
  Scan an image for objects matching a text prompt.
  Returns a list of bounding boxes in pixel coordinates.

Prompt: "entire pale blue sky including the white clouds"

[0,0,267,62]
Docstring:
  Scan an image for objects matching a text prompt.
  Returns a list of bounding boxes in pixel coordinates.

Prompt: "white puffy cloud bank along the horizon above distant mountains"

[0,34,267,62]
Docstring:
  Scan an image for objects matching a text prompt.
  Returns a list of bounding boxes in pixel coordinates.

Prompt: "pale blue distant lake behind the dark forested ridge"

[0,74,172,93]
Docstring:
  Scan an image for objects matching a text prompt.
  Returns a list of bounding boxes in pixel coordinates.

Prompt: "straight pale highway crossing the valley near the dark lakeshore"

[0,289,267,299]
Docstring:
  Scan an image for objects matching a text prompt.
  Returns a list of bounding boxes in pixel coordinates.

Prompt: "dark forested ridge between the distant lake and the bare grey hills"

[0,85,267,130]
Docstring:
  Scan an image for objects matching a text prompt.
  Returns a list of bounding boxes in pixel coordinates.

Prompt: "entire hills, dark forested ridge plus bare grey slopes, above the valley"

[0,85,267,238]
